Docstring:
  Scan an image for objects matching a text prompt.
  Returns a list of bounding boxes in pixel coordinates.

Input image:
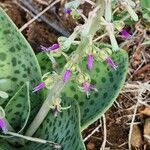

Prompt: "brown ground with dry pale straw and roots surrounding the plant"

[0,0,150,150]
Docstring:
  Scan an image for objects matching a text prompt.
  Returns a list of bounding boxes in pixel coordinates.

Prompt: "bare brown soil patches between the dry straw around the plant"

[0,0,150,150]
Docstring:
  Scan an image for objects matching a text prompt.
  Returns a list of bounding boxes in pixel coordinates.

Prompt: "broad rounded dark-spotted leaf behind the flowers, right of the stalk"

[39,44,128,130]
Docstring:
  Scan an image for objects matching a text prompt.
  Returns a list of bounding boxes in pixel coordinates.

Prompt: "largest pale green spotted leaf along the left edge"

[0,8,43,120]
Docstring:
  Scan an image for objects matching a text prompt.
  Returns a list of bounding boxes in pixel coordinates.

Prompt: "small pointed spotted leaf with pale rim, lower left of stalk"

[0,83,30,145]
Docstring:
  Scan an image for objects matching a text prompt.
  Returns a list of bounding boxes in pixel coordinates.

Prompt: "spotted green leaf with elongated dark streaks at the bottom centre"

[24,97,85,150]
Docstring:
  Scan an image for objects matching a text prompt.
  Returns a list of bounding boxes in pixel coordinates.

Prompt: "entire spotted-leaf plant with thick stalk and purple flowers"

[0,0,140,150]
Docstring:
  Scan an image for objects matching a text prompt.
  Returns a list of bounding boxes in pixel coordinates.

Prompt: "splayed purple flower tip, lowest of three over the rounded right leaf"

[82,82,98,97]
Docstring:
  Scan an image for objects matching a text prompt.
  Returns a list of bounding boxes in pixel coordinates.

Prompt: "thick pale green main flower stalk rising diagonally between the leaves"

[25,0,104,136]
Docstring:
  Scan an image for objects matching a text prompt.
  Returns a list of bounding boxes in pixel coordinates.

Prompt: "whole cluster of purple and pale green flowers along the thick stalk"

[33,0,134,116]
